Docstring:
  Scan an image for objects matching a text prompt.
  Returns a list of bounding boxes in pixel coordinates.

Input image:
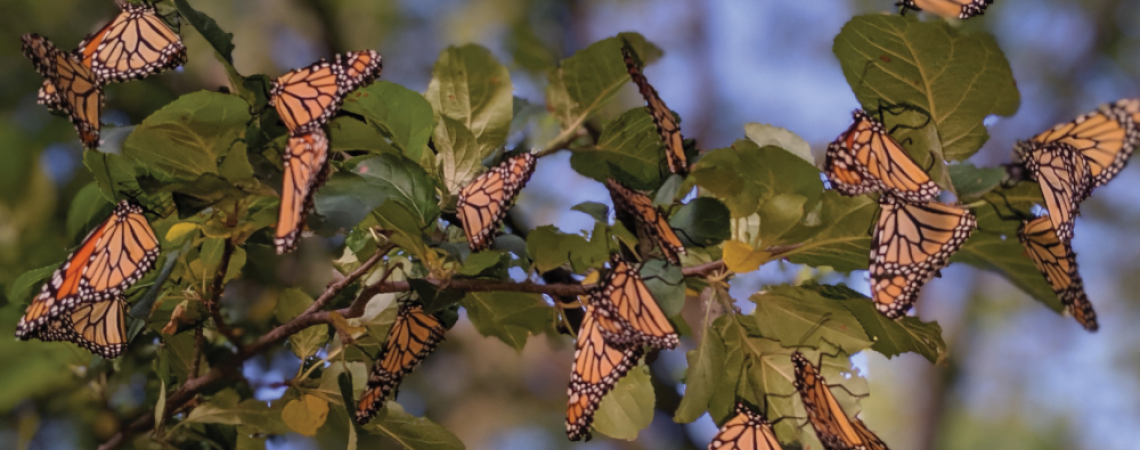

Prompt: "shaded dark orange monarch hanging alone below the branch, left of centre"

[356,302,447,425]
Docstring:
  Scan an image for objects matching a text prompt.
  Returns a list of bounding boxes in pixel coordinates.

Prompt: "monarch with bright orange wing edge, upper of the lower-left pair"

[16,201,158,346]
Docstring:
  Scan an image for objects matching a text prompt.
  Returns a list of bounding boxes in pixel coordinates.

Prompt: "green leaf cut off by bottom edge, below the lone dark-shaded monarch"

[364,401,464,450]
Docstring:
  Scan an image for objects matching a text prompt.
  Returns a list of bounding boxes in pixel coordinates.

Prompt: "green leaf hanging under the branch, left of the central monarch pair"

[459,292,555,352]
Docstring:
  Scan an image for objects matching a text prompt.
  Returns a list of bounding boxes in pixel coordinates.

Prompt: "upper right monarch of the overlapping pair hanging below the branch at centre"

[589,253,678,350]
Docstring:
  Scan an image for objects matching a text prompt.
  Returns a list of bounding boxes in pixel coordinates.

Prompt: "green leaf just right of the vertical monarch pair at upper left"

[343,81,435,162]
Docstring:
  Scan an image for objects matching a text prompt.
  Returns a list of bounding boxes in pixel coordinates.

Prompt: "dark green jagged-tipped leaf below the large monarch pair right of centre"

[805,285,946,362]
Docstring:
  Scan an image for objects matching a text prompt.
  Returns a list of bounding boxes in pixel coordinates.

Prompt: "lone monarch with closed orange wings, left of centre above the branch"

[456,153,538,252]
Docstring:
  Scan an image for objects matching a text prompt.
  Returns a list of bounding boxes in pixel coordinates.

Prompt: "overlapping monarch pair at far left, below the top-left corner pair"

[16,201,158,358]
